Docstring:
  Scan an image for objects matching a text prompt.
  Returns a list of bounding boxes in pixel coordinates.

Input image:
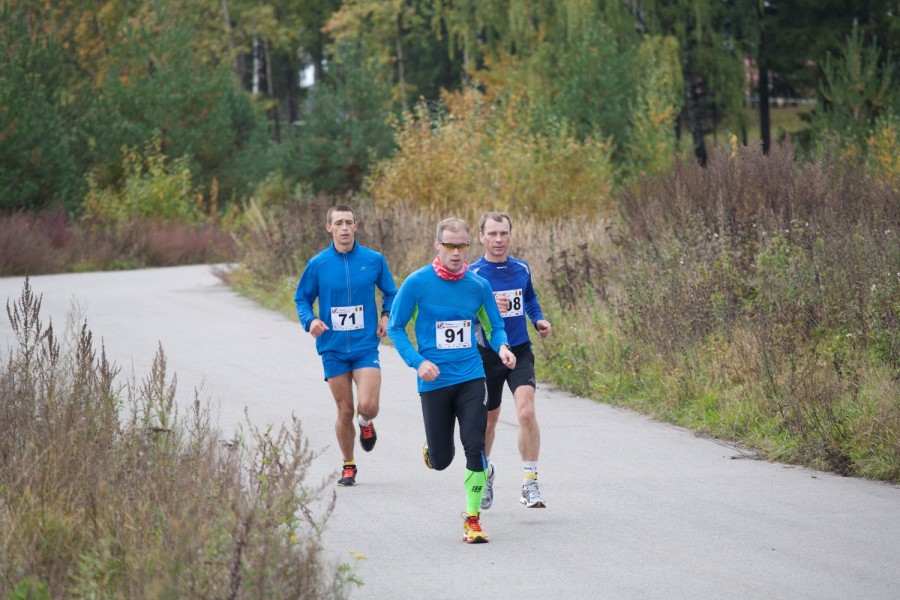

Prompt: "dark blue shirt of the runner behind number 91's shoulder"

[469,256,544,346]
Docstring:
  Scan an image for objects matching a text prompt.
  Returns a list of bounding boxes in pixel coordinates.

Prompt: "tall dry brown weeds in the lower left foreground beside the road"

[0,279,352,599]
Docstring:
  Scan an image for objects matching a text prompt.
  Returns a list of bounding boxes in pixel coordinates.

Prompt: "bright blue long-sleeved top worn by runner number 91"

[388,265,507,392]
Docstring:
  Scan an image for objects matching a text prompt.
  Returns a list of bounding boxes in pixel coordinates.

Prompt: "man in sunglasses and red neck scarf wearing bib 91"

[388,218,516,544]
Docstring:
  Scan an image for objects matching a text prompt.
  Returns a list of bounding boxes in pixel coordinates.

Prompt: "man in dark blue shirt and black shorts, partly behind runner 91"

[471,212,551,510]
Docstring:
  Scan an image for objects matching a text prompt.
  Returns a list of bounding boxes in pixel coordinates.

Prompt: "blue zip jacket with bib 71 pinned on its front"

[294,242,397,355]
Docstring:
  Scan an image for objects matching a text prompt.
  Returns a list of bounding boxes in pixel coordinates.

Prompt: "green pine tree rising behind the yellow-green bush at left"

[93,2,268,198]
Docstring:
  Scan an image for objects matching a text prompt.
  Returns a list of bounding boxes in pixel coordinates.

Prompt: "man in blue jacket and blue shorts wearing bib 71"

[294,204,397,486]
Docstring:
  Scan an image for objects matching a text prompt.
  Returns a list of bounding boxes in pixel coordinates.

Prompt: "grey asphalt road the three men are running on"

[0,266,900,600]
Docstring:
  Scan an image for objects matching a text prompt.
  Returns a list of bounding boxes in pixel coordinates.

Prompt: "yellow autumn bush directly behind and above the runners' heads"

[366,89,615,218]
